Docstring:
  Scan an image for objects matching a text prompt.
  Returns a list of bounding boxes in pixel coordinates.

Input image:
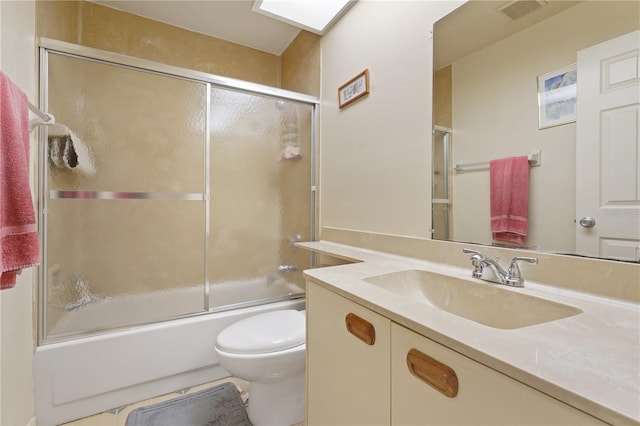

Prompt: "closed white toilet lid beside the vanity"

[216,309,305,354]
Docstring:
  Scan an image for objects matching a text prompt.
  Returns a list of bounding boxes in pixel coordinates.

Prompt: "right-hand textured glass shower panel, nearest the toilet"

[208,88,312,308]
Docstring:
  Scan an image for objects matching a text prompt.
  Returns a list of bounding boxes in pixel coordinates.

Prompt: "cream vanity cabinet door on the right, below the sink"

[391,324,604,426]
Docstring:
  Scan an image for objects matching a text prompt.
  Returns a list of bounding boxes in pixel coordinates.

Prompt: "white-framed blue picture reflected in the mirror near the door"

[538,64,578,129]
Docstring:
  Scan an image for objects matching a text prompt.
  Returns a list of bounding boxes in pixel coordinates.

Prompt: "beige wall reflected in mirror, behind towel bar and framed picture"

[452,1,640,253]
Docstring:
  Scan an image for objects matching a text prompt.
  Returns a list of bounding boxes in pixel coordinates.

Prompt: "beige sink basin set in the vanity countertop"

[364,270,582,330]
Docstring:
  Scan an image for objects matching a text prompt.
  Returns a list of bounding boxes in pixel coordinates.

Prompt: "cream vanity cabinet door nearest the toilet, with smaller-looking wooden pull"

[307,281,391,426]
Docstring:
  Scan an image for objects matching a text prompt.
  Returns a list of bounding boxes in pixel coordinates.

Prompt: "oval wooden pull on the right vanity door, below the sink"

[407,349,458,398]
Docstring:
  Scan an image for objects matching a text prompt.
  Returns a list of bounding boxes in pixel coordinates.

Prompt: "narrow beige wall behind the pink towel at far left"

[0,1,37,425]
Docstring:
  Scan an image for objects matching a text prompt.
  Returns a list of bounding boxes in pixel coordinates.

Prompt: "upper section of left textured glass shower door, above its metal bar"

[47,54,206,192]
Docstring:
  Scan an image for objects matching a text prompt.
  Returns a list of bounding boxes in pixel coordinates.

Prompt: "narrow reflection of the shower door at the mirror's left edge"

[431,125,451,240]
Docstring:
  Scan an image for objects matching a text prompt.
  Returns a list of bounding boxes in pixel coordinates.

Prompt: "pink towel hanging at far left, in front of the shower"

[0,72,40,289]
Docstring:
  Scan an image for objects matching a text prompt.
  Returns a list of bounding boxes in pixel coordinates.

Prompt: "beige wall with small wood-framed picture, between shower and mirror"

[320,1,460,237]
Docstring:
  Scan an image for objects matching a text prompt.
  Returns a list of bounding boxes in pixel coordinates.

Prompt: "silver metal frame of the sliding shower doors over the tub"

[37,38,320,345]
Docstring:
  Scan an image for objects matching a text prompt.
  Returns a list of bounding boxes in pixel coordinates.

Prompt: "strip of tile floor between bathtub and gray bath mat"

[60,377,304,426]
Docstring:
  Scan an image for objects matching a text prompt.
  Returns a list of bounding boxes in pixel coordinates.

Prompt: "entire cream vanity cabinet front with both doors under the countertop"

[307,281,605,426]
